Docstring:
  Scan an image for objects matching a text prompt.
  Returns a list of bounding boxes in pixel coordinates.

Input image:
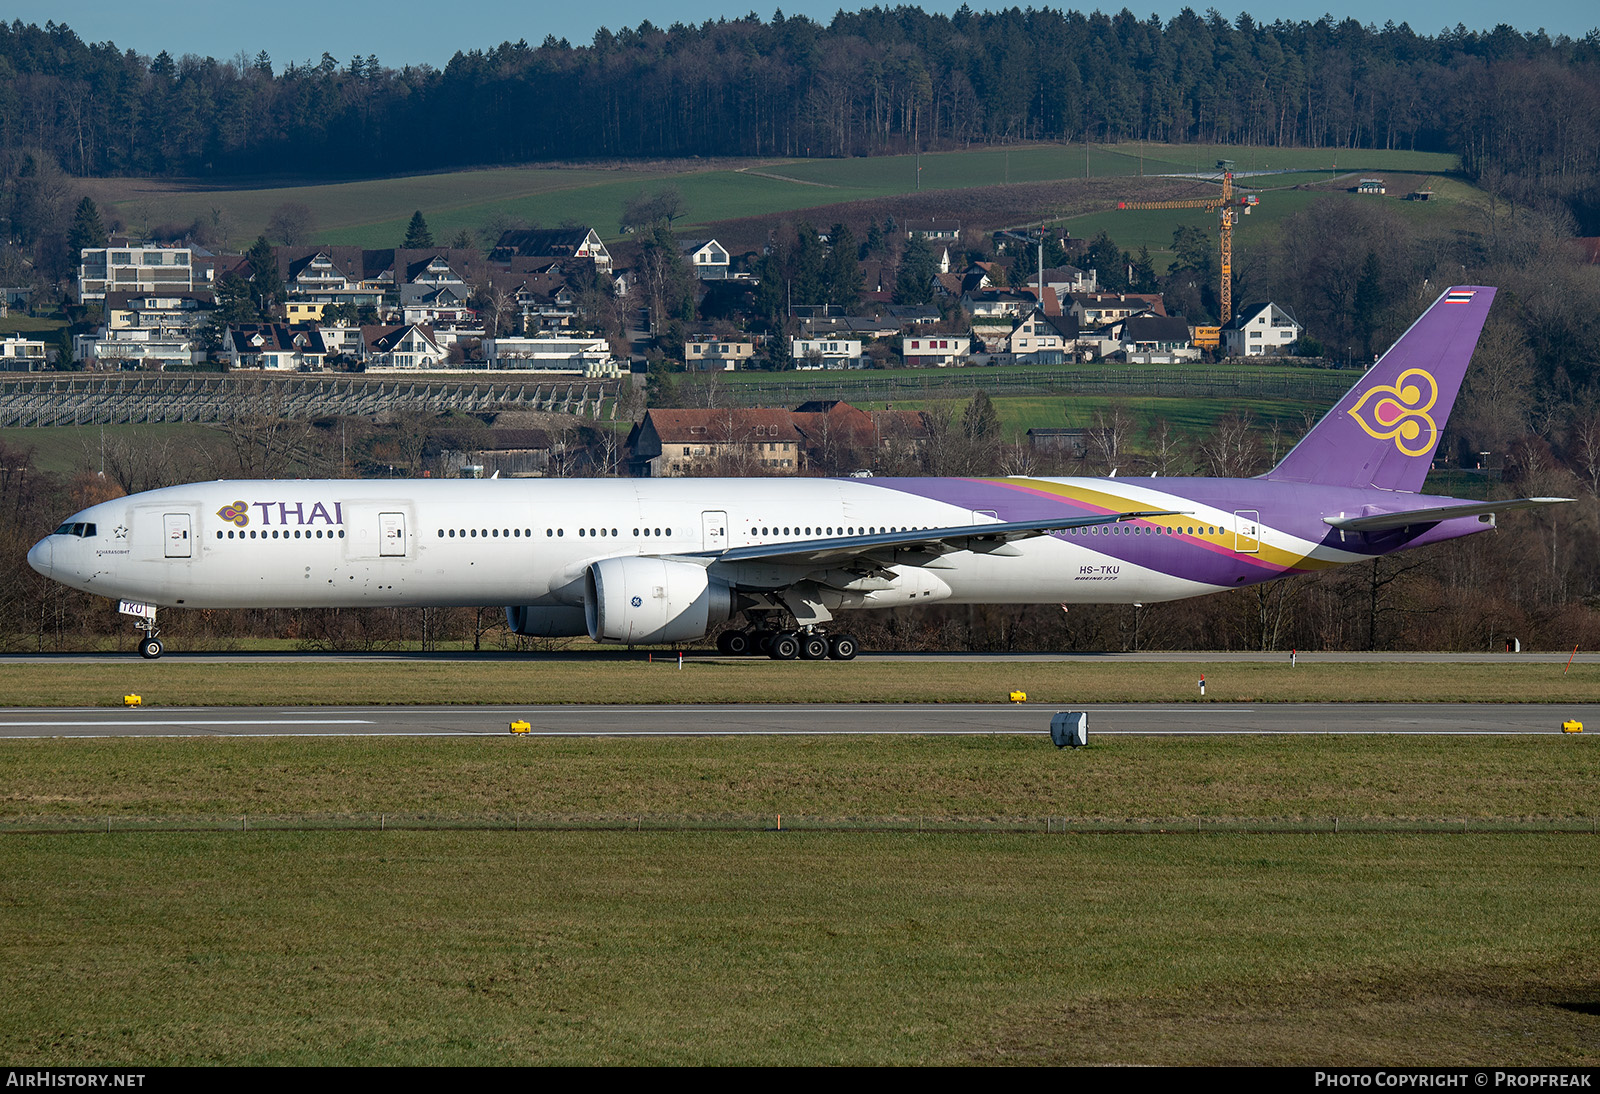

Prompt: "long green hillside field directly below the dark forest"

[86,144,1456,250]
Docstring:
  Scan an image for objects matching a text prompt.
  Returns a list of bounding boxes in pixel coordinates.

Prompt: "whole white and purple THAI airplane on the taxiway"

[27,285,1570,661]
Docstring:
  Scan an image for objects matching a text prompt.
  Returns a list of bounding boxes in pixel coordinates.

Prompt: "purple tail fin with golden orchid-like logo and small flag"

[1266,285,1494,493]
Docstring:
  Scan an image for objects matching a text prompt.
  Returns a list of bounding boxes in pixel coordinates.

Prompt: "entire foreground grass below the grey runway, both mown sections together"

[0,737,1600,1067]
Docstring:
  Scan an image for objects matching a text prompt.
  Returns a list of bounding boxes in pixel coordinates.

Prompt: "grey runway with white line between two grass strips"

[0,704,1600,739]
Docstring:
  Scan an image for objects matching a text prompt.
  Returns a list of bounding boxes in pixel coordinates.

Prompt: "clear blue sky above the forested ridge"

[15,0,1600,69]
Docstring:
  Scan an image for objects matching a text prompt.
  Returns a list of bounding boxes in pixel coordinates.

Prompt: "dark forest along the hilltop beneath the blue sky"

[0,6,1600,222]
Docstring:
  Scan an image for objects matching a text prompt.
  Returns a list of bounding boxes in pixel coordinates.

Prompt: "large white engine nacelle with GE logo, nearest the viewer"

[584,558,733,645]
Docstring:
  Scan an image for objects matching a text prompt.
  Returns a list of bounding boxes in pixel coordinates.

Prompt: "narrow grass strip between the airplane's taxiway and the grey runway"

[0,651,1600,707]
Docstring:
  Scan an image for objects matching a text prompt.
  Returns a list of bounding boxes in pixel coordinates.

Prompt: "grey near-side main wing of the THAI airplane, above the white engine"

[680,509,1178,568]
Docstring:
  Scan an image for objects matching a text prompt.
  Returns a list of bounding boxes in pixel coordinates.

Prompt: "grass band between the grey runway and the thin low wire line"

[0,733,1600,828]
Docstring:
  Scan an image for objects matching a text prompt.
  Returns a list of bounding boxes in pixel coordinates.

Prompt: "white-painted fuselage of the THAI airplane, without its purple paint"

[30,478,1312,608]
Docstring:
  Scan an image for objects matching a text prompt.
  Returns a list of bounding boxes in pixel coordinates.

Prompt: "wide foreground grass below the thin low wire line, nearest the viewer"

[0,832,1600,1067]
